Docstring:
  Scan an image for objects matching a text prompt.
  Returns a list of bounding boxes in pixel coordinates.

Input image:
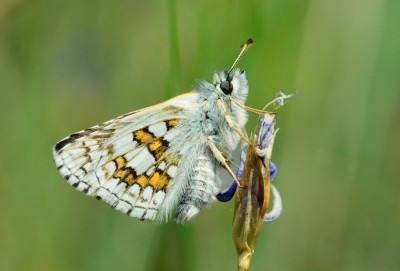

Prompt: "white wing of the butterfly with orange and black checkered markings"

[53,93,196,220]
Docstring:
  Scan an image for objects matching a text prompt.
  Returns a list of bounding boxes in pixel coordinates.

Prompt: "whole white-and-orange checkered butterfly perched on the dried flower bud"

[53,39,264,223]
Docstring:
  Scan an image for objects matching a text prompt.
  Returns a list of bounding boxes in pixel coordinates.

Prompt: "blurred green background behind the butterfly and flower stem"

[0,0,400,270]
